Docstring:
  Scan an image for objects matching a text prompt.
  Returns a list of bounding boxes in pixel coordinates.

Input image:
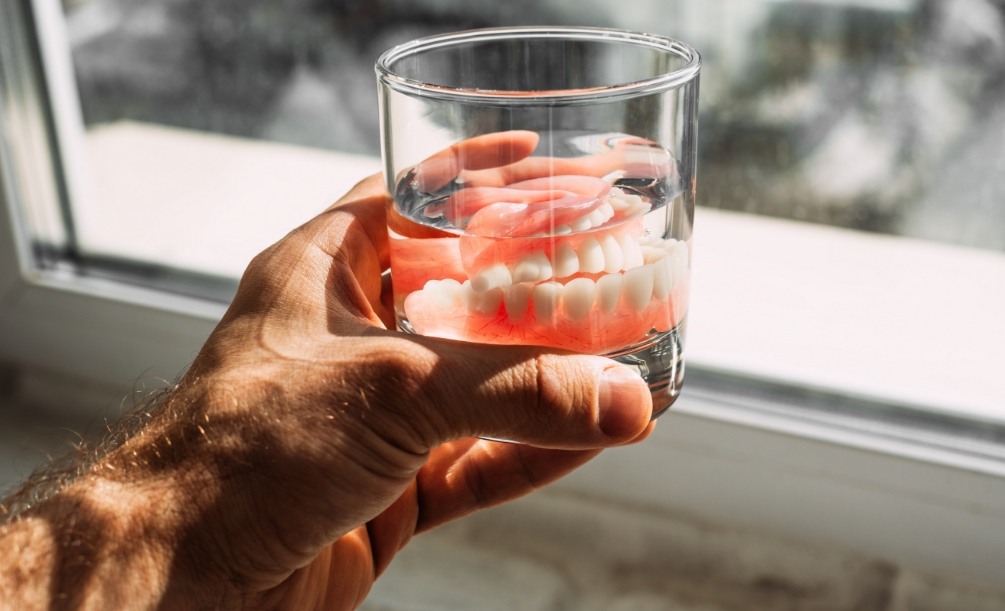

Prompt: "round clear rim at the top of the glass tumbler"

[374,26,701,106]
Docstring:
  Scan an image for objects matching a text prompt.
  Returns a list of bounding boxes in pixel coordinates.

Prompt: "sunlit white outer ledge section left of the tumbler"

[74,122,381,277]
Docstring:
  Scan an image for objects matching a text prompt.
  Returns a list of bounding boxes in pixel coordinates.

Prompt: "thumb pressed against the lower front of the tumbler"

[387,336,652,449]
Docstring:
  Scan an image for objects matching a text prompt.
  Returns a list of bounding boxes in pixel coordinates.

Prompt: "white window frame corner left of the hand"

[0,0,224,388]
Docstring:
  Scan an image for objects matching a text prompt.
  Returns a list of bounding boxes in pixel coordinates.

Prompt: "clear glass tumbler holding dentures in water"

[376,27,700,415]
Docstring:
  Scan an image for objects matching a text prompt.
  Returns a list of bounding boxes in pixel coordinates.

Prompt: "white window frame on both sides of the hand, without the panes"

[0,0,1005,585]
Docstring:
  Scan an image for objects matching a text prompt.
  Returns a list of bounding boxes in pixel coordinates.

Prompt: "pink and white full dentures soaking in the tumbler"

[391,175,688,353]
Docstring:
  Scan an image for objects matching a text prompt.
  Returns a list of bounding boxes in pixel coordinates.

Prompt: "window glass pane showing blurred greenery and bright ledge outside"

[17,0,1005,418]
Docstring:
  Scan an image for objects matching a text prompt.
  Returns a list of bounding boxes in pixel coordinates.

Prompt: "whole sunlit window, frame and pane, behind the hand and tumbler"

[0,0,1005,590]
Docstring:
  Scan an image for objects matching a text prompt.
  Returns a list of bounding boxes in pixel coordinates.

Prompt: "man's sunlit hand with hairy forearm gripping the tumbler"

[0,135,651,609]
